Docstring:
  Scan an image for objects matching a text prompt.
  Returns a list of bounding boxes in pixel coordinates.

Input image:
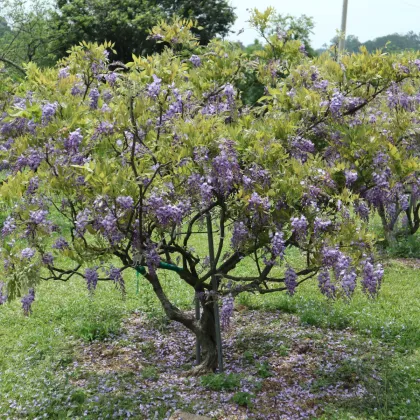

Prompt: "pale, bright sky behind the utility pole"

[229,0,420,49]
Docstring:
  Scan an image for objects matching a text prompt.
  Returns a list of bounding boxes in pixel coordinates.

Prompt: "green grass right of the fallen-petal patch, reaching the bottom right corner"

[239,262,420,419]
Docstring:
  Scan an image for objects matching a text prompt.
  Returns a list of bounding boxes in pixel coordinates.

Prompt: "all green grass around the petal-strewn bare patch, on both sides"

[0,244,420,419]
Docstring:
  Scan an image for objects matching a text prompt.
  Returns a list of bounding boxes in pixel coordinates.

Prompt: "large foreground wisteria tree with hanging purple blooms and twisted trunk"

[0,14,419,373]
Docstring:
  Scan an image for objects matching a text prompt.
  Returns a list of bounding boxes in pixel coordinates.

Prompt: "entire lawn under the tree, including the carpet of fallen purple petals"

[0,254,420,419]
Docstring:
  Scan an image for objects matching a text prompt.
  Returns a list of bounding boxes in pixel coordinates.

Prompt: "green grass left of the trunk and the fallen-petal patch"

[0,268,192,418]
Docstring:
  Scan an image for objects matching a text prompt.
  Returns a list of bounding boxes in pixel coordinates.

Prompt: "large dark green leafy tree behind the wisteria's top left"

[54,0,235,62]
